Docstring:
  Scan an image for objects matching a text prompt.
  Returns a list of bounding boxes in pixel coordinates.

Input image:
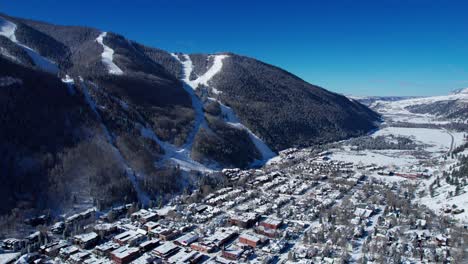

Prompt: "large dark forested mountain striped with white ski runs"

[0,14,379,213]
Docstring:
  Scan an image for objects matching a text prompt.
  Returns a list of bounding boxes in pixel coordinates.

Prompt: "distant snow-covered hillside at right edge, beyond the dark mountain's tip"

[371,88,468,121]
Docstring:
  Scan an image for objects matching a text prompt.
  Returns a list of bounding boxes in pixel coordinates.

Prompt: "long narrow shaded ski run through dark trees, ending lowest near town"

[80,78,151,206]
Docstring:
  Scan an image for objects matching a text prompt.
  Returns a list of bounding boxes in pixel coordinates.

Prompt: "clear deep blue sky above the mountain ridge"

[0,0,468,95]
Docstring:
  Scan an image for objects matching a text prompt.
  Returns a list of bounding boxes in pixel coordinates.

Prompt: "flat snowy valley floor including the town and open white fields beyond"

[0,90,468,263]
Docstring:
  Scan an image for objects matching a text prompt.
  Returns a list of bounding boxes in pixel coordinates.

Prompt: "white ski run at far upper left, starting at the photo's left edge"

[0,17,59,75]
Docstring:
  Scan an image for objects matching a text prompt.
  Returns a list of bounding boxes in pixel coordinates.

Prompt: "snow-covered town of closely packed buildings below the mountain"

[2,142,467,264]
